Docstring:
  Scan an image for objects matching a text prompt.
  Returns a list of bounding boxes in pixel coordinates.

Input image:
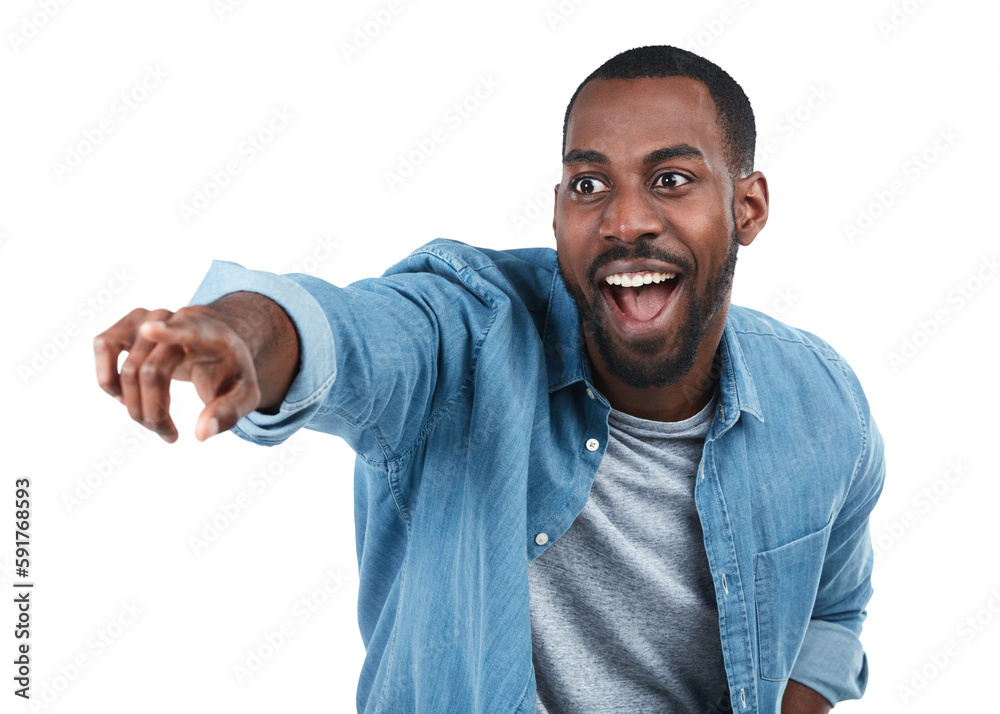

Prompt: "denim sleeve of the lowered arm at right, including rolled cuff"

[790,396,885,704]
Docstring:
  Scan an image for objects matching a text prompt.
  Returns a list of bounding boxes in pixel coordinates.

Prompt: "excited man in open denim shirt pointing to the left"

[95,47,884,714]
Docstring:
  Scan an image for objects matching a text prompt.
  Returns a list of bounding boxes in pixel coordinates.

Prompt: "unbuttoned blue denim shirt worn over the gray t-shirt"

[192,239,885,714]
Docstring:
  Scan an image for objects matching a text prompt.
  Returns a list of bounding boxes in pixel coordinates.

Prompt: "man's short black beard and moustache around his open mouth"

[556,214,739,389]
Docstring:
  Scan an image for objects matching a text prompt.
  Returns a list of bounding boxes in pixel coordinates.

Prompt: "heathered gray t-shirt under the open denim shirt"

[528,396,732,714]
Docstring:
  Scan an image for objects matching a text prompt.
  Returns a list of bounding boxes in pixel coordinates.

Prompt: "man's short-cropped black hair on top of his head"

[562,45,757,176]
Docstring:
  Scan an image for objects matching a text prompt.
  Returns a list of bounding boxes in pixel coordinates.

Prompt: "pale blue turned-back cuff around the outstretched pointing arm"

[188,260,337,446]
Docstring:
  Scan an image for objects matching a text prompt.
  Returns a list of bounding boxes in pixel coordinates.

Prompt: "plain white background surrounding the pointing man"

[0,0,1000,714]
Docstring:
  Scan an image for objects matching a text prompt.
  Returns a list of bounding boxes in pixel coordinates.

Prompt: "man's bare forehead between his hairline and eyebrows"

[566,77,723,163]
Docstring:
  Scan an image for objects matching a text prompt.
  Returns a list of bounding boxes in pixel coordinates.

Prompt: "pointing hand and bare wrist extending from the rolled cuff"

[94,292,299,443]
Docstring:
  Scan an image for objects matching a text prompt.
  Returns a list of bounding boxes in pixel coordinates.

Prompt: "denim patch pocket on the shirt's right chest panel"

[753,518,833,681]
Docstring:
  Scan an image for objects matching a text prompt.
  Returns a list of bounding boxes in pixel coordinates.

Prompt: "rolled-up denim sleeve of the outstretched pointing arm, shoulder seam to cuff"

[192,246,494,461]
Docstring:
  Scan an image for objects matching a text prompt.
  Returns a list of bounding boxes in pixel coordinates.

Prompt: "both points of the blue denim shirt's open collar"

[542,270,764,422]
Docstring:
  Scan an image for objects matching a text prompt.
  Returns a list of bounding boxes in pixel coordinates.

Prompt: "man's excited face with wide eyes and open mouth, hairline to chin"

[552,77,738,389]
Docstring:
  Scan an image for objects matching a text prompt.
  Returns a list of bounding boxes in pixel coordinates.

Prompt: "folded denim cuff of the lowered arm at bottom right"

[789,620,868,704]
